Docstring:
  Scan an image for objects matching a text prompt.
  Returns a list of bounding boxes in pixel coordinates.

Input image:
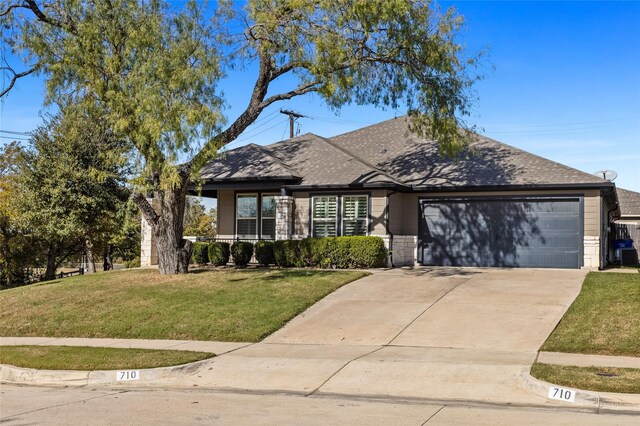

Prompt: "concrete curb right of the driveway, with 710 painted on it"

[520,369,640,413]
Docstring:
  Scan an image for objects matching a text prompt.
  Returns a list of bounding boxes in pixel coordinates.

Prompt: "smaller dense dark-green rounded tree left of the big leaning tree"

[16,109,129,279]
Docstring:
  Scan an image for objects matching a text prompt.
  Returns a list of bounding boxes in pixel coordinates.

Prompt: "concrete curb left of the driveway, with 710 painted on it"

[0,358,213,386]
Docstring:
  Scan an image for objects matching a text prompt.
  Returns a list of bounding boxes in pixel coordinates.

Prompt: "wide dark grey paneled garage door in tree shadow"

[418,197,583,268]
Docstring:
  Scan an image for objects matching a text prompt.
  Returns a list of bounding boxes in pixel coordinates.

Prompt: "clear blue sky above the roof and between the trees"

[0,1,640,208]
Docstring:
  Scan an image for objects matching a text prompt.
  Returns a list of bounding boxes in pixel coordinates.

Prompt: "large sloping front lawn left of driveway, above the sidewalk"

[0,269,366,342]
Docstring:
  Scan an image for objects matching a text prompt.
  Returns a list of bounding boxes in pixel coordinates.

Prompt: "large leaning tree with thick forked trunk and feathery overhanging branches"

[0,0,478,274]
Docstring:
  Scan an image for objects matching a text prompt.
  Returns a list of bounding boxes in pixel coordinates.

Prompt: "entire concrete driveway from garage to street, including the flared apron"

[184,268,586,405]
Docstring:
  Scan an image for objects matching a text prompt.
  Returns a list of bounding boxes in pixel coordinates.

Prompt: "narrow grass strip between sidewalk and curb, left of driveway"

[0,346,214,371]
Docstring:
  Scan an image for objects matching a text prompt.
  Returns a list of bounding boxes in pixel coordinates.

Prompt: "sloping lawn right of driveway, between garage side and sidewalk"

[541,272,640,356]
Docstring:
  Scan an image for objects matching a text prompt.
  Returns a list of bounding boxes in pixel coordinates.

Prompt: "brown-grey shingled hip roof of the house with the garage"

[202,117,611,190]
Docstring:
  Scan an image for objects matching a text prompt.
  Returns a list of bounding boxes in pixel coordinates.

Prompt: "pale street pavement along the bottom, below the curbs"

[0,384,640,426]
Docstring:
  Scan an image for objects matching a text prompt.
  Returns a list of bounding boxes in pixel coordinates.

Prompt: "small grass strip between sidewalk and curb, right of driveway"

[531,363,640,393]
